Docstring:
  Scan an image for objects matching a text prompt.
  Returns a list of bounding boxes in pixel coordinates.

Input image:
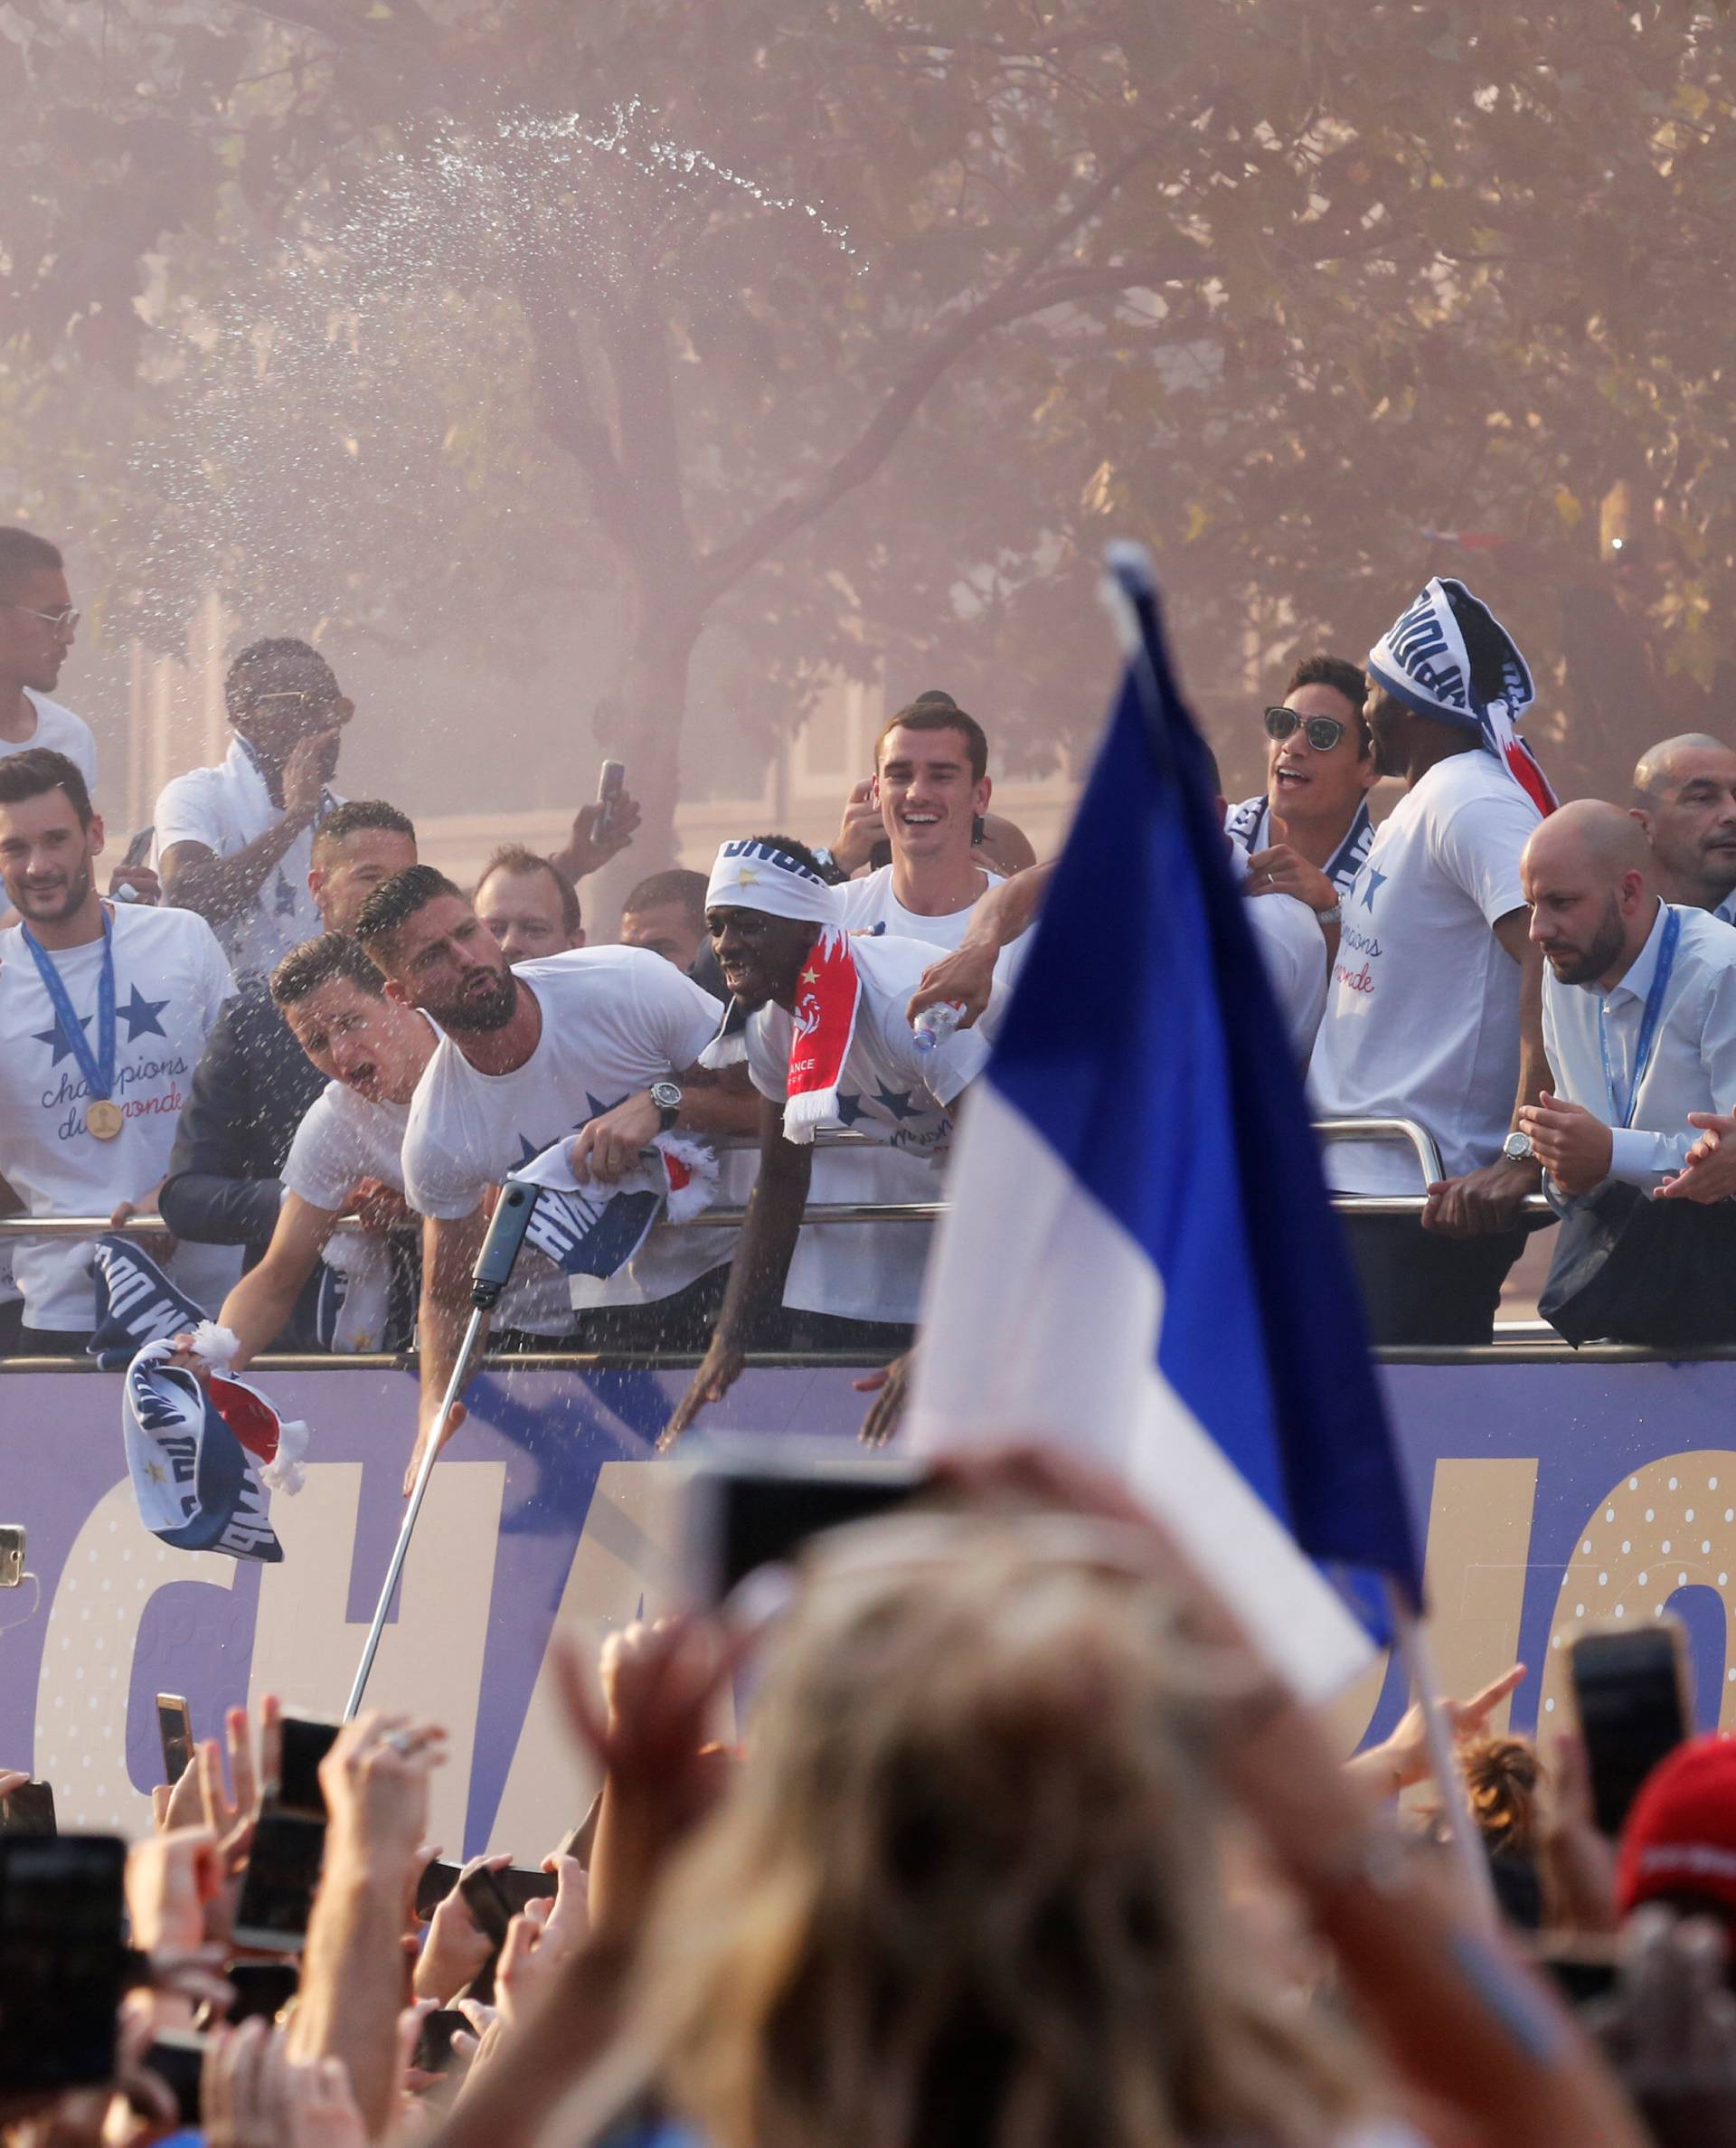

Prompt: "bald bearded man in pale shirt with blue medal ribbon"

[1519,800,1736,1203]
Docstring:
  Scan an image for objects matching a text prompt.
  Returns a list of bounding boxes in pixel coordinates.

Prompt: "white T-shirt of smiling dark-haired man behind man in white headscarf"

[784,866,1009,1325]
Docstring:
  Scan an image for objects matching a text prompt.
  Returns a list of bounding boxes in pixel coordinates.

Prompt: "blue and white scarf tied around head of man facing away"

[1369,576,1560,814]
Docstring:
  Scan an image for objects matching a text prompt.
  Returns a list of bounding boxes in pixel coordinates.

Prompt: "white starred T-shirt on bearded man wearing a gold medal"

[0,903,241,1334]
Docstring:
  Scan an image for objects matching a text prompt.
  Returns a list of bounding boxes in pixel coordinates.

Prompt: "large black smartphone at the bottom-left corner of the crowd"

[0,1834,127,2092]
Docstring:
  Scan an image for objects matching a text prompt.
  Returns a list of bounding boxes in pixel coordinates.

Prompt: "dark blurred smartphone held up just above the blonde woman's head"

[685,1439,929,1603]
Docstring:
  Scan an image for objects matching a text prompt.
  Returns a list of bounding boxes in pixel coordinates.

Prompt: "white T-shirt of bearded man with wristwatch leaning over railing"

[404,947,735,1334]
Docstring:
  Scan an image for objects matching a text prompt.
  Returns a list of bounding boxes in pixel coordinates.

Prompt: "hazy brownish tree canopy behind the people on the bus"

[0,0,1736,827]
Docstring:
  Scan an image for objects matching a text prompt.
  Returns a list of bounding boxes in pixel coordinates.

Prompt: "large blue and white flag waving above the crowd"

[907,563,1422,1699]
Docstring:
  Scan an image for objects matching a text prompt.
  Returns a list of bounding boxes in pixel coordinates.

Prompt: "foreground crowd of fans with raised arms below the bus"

[0,1450,1736,2148]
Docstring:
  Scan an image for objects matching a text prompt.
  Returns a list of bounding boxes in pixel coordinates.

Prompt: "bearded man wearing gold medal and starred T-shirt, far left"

[0,748,236,1356]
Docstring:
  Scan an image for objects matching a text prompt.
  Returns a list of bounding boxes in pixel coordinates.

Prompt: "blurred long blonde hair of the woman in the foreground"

[584,1517,1360,2148]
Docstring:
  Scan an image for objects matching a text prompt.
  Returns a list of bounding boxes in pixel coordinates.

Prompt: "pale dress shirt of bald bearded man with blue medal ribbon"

[1543,903,1736,1188]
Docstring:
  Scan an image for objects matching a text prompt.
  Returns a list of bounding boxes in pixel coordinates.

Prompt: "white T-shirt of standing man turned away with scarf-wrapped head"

[1306,750,1538,1195]
